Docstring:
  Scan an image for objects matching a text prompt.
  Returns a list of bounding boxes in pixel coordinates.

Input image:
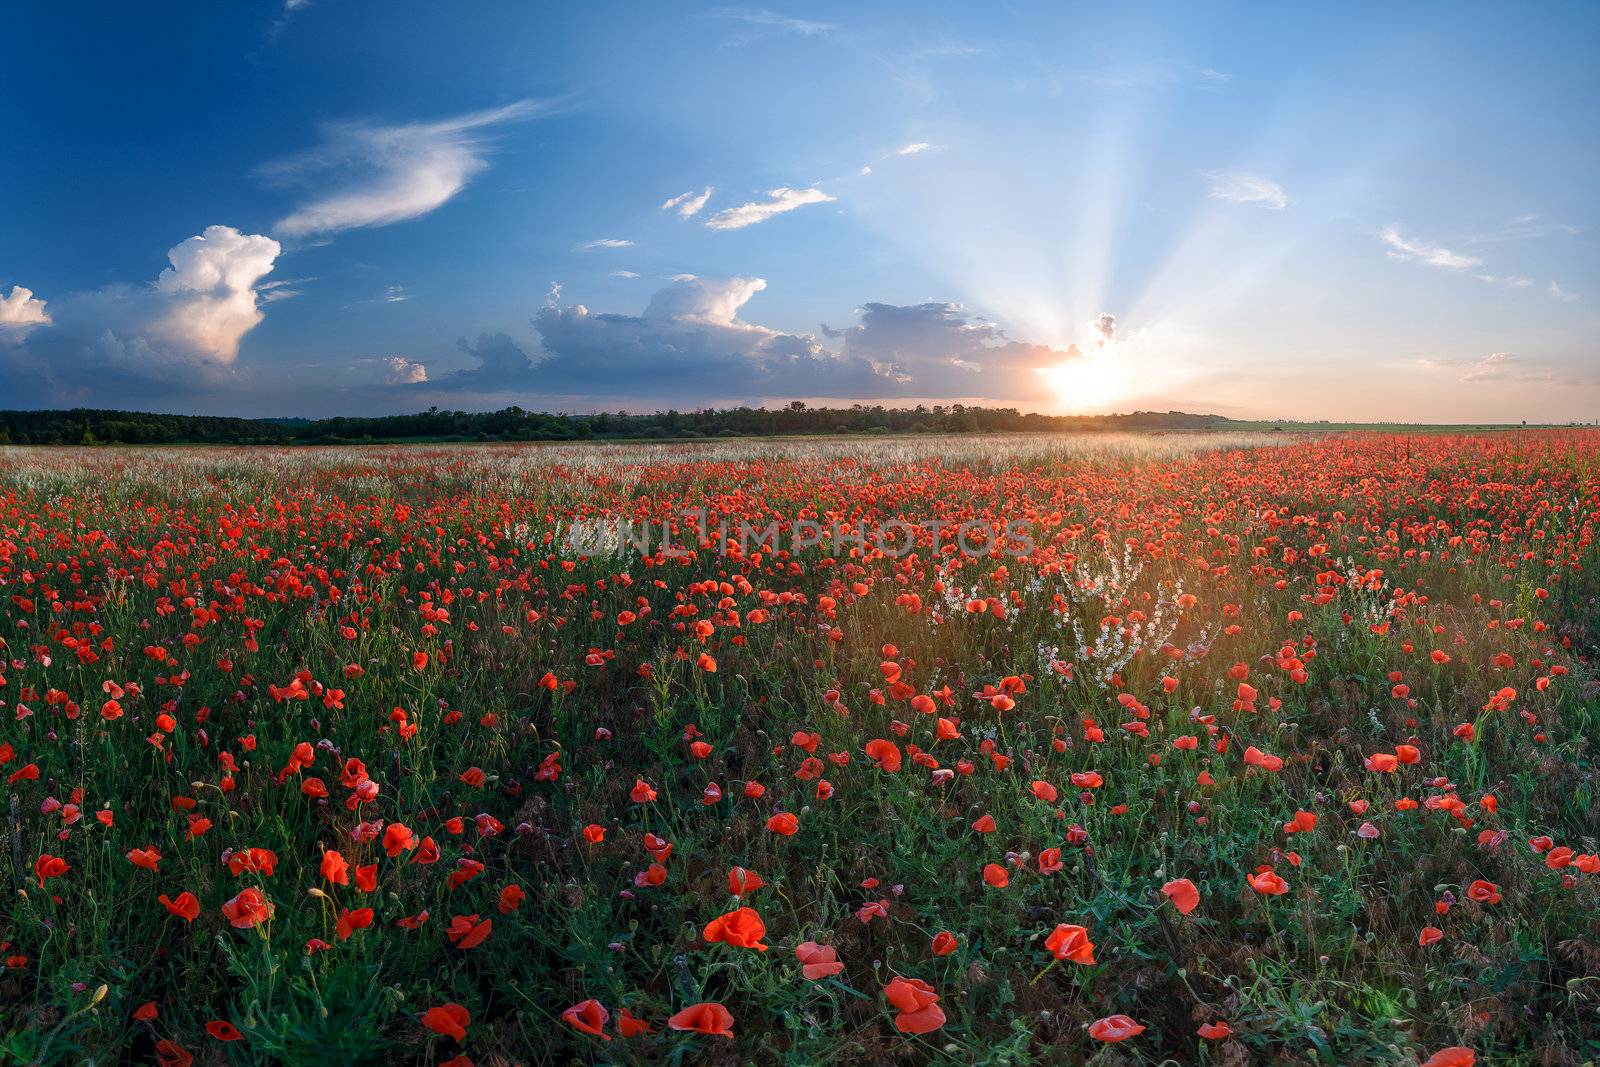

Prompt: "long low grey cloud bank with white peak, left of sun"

[429,275,1077,402]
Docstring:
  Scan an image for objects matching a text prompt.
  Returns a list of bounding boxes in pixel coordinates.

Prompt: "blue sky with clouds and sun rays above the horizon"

[0,0,1600,421]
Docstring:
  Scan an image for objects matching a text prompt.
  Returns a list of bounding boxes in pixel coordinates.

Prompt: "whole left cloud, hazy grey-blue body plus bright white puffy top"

[0,226,280,405]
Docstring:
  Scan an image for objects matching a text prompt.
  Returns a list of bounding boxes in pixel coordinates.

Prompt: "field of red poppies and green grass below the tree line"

[0,429,1600,1067]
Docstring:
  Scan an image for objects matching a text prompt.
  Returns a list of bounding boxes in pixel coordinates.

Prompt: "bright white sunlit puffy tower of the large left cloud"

[152,226,282,363]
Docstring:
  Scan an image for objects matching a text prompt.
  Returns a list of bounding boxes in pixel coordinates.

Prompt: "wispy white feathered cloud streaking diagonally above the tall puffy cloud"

[267,101,547,237]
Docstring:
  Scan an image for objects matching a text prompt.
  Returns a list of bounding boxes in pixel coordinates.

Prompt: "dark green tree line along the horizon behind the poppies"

[0,400,1229,445]
